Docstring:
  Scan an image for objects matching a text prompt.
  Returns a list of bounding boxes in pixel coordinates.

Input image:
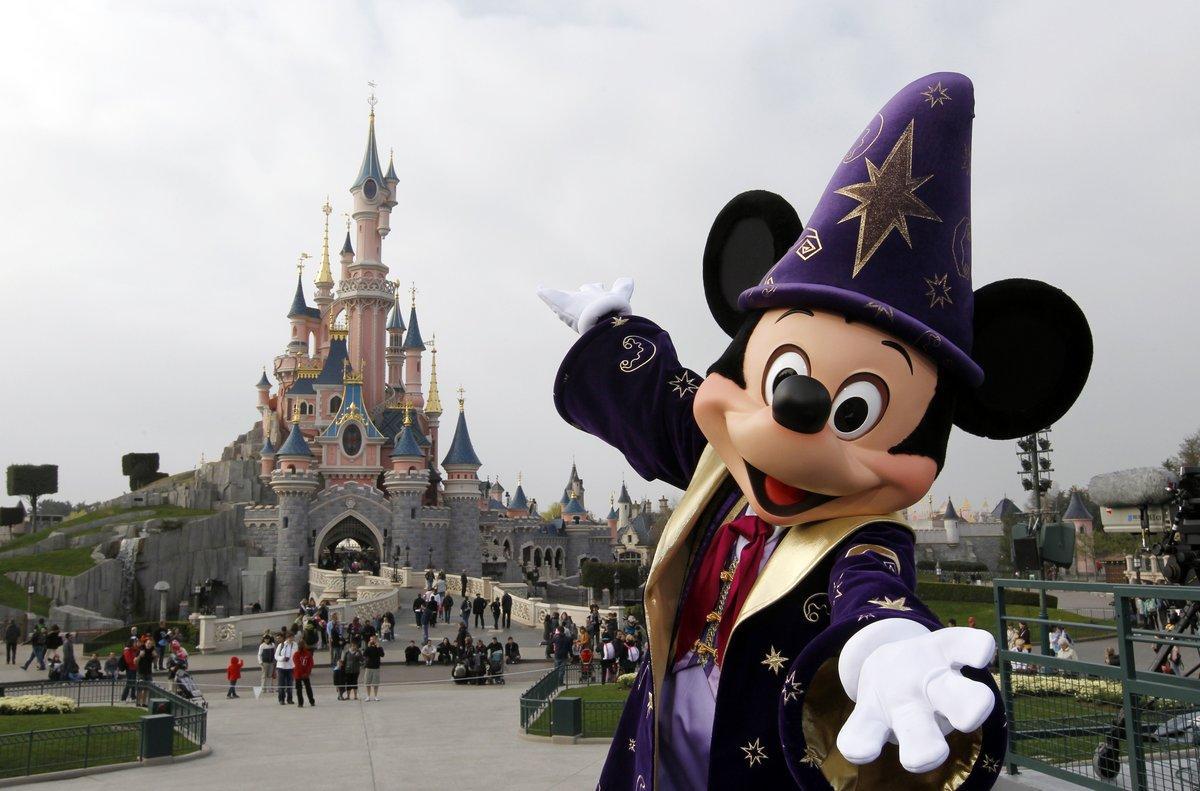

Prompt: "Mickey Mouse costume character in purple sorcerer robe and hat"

[539,73,1092,791]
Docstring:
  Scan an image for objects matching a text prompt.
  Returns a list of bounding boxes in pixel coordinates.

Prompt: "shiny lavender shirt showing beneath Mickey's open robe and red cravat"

[658,509,787,791]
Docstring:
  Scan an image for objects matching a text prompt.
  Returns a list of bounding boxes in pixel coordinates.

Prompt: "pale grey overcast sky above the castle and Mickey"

[0,0,1200,510]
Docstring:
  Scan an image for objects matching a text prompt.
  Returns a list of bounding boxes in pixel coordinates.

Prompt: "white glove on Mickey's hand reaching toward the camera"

[838,618,996,773]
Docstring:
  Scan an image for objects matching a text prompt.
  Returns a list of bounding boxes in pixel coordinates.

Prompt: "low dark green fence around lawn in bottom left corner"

[0,678,208,778]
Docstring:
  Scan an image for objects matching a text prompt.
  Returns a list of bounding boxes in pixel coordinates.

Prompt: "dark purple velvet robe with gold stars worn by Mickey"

[554,316,1007,791]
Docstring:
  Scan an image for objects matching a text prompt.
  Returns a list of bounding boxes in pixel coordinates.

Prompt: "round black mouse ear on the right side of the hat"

[954,280,1092,439]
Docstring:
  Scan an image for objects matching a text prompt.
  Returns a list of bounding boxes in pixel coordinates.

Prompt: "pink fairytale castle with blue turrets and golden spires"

[242,97,648,607]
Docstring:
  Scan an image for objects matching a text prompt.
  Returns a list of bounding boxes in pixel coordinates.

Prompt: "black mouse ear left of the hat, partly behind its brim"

[704,190,804,336]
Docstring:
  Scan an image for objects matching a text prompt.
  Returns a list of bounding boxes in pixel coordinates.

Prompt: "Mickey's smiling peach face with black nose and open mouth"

[694,308,937,525]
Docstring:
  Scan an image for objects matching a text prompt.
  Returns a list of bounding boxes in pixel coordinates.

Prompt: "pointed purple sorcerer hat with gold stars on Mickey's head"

[738,72,983,386]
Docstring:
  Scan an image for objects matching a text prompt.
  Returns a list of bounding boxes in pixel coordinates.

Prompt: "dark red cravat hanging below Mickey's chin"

[676,515,774,665]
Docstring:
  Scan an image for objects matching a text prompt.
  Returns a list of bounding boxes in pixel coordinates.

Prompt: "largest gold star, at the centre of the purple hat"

[835,121,942,277]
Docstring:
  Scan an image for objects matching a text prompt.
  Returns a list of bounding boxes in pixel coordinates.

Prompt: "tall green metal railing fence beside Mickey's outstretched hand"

[995,580,1200,791]
